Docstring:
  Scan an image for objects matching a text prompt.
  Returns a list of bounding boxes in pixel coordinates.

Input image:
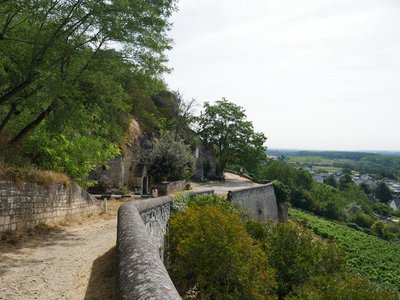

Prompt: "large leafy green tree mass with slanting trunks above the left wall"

[0,0,175,179]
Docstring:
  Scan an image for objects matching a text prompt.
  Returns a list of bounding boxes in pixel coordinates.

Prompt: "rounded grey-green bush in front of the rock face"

[148,131,195,181]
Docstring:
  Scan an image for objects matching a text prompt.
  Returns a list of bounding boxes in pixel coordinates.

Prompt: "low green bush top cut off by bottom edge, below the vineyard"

[286,273,398,300]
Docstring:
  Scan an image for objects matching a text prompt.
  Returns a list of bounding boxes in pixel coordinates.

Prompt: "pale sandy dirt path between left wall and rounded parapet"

[0,200,126,300]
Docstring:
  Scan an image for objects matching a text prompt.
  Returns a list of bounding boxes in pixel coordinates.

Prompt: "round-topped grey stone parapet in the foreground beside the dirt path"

[117,197,181,300]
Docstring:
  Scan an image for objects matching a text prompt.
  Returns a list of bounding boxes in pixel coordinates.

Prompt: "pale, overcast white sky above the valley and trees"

[165,0,400,151]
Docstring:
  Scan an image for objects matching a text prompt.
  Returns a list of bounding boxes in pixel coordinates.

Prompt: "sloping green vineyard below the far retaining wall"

[289,209,400,290]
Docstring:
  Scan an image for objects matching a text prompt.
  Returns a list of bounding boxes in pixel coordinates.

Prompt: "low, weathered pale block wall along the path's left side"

[0,181,102,232]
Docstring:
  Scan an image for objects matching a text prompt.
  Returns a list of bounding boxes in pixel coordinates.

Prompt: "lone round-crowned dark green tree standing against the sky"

[197,98,266,174]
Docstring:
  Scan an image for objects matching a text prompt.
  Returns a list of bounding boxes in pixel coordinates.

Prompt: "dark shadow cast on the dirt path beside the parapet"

[85,246,117,300]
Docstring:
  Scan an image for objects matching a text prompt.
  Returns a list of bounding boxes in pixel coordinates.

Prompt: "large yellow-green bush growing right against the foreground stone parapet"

[169,202,275,299]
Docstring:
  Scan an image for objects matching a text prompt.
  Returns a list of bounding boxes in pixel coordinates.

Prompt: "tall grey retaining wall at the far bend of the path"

[228,183,281,222]
